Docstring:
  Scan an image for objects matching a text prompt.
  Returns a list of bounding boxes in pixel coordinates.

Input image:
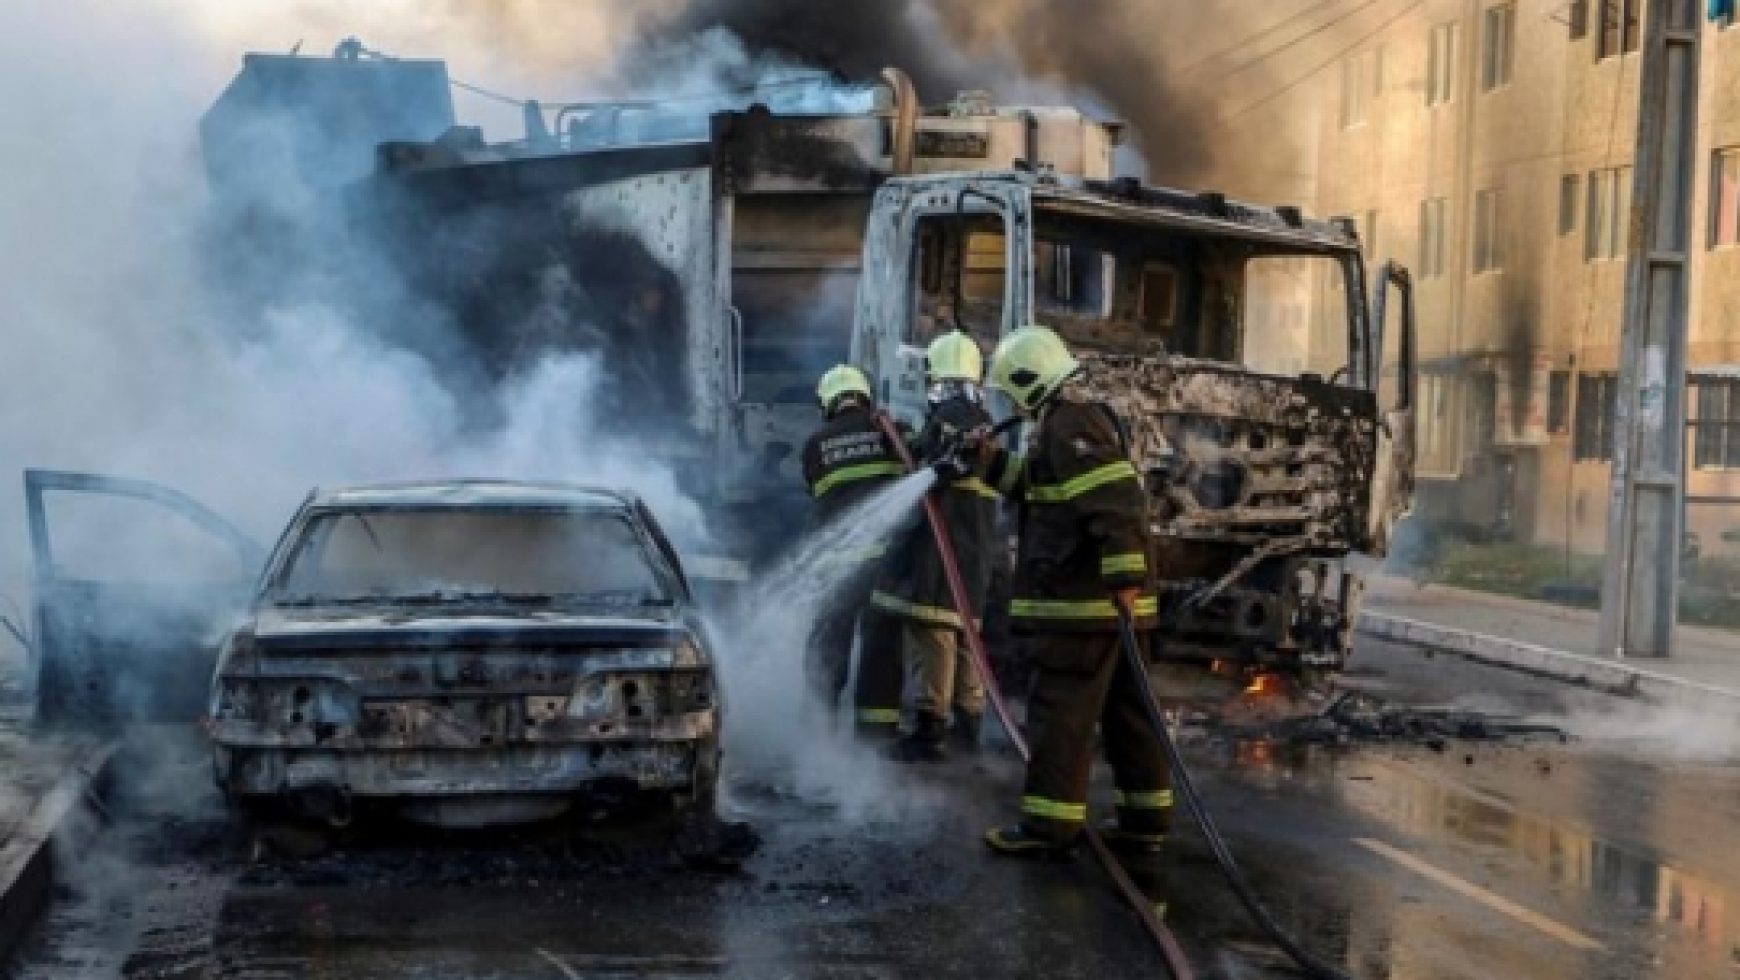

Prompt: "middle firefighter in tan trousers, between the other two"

[876,331,997,762]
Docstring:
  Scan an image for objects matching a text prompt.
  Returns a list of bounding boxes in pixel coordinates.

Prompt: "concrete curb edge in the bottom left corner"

[0,743,115,961]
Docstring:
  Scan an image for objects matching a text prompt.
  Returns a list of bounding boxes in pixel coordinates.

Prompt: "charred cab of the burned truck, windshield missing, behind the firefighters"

[853,171,1415,691]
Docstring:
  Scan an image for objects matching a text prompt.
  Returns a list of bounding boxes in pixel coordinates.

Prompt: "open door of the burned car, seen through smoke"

[24,470,264,724]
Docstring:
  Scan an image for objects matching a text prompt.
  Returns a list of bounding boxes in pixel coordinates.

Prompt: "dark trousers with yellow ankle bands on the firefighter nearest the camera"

[1021,632,1173,842]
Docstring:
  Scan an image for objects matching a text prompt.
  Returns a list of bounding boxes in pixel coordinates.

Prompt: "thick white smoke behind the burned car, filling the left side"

[0,0,701,668]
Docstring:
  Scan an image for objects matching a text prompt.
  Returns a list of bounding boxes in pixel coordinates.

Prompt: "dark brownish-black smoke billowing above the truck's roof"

[653,0,1336,188]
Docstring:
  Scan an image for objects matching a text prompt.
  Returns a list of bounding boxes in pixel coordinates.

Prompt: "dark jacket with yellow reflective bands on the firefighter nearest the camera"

[983,393,1157,632]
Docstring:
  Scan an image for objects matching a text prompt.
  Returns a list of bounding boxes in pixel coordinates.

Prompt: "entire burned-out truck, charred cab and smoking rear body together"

[202,45,1413,677]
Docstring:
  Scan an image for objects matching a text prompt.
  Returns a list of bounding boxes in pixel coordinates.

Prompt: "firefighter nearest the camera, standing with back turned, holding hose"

[976,326,1173,855]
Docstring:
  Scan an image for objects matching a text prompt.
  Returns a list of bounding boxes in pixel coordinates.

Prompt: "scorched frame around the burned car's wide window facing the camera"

[259,503,686,611]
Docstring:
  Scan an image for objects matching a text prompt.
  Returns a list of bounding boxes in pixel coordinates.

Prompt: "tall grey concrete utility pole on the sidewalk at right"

[1594,0,1703,658]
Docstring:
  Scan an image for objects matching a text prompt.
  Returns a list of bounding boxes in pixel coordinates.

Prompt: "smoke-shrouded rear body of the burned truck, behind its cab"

[202,45,1121,567]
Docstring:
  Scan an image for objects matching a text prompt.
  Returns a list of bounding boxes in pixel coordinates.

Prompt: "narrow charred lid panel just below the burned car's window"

[254,607,687,651]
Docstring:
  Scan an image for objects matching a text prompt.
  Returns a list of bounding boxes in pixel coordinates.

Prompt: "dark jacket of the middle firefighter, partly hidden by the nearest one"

[870,397,997,628]
